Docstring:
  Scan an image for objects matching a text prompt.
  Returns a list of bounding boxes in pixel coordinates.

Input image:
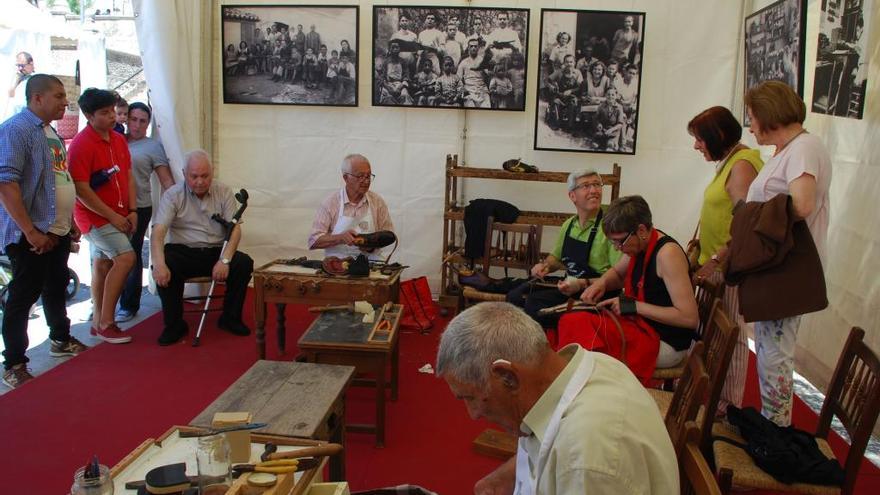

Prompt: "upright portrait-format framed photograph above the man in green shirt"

[535,9,645,155]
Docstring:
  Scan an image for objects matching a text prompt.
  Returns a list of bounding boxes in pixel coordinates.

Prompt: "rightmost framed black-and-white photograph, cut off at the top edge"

[812,0,876,119]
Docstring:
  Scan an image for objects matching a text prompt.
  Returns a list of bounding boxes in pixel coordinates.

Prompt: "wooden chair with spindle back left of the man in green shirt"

[461,217,541,306]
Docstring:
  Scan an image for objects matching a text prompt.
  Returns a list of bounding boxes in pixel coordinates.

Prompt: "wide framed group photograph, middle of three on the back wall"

[373,6,529,111]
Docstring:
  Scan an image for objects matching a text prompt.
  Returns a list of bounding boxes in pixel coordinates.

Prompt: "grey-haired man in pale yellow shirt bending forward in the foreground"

[437,302,679,495]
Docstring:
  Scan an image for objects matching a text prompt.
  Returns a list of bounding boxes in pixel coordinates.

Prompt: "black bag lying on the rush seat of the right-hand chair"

[714,405,845,486]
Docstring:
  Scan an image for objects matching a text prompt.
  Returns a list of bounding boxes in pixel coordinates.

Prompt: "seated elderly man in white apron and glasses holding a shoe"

[309,155,394,260]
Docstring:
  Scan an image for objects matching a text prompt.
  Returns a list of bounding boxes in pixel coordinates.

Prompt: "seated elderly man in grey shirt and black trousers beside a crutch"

[150,150,254,346]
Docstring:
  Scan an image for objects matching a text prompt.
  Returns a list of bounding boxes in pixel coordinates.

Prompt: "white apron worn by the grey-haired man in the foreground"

[513,352,595,495]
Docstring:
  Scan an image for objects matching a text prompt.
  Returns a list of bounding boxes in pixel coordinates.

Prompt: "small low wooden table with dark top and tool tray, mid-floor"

[298,304,403,447]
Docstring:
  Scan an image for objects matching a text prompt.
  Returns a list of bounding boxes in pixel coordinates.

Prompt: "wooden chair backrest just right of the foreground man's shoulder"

[664,342,709,456]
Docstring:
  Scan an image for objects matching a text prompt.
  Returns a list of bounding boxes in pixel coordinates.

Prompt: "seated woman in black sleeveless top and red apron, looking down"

[558,196,699,384]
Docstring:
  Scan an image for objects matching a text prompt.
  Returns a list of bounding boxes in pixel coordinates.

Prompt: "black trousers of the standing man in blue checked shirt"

[3,235,70,369]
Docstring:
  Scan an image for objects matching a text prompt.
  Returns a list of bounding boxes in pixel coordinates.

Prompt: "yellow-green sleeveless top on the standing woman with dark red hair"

[700,148,764,265]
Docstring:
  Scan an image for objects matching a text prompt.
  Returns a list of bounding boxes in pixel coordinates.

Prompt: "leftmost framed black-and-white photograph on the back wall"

[220,5,359,107]
